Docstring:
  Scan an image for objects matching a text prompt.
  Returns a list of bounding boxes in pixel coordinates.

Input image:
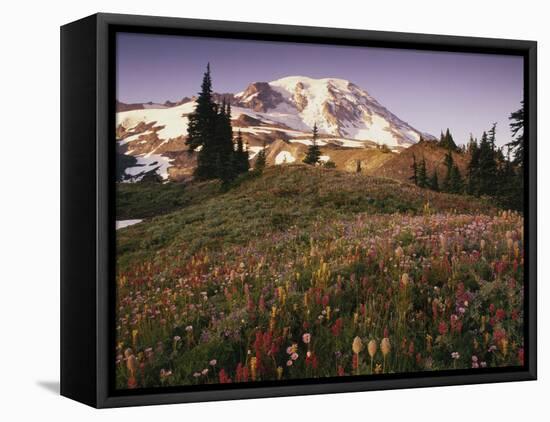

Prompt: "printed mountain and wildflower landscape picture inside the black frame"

[112,33,524,390]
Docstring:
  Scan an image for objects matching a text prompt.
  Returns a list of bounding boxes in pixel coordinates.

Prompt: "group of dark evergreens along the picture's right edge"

[410,102,524,210]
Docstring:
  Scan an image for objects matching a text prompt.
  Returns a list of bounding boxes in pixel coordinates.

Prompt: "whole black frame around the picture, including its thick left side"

[61,13,537,408]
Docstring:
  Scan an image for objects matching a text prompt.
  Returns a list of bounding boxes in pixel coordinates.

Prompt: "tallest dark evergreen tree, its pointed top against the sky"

[185,64,218,179]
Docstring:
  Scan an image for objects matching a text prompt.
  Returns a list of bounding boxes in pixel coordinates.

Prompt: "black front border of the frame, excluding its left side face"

[86,13,537,408]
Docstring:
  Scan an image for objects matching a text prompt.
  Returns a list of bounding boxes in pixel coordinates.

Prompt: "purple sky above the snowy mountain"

[117,33,523,145]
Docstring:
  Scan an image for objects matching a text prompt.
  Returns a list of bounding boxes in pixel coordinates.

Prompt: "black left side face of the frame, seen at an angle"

[60,16,101,406]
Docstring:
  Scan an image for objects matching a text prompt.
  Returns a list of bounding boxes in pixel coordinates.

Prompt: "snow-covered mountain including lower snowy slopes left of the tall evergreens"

[117,76,433,180]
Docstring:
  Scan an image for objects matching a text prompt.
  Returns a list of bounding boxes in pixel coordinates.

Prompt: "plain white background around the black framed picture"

[0,0,550,422]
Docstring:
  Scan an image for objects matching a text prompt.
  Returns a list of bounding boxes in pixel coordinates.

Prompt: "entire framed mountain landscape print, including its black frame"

[61,14,536,407]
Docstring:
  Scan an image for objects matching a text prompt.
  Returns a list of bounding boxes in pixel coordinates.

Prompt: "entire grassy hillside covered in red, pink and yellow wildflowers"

[116,166,523,388]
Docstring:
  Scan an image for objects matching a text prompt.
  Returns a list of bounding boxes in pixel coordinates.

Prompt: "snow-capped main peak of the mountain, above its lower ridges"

[235,76,431,147]
